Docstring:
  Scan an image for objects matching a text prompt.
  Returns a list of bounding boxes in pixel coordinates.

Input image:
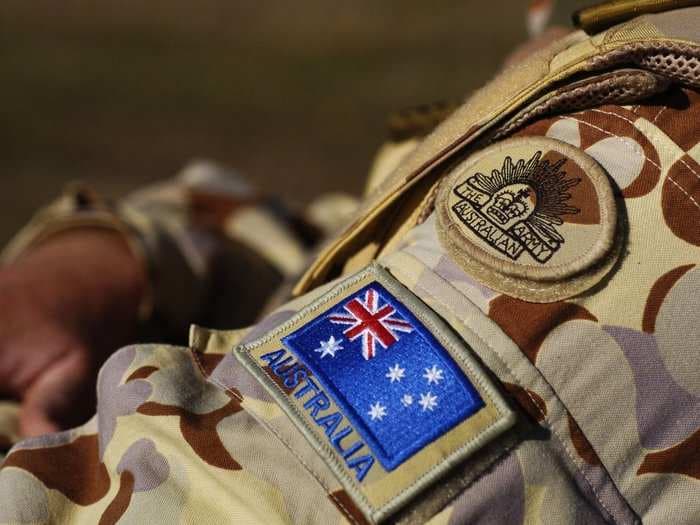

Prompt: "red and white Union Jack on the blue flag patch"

[328,288,413,359]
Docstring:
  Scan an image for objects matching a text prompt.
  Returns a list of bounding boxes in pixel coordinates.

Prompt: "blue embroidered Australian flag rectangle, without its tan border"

[282,281,484,470]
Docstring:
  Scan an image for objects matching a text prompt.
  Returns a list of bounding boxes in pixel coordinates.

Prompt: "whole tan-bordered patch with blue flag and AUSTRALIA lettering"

[235,265,514,522]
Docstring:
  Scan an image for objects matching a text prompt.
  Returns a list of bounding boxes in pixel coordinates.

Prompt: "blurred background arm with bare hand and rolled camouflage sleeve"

[0,162,353,441]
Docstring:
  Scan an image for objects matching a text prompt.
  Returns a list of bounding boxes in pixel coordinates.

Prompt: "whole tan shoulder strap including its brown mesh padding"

[295,7,700,294]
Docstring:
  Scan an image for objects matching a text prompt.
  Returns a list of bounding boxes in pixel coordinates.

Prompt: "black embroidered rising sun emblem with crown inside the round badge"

[452,151,581,263]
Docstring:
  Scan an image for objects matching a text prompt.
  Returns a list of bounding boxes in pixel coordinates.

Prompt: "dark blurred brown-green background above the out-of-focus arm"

[0,0,526,243]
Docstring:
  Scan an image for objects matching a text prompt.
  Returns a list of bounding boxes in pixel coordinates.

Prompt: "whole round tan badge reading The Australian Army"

[436,137,617,302]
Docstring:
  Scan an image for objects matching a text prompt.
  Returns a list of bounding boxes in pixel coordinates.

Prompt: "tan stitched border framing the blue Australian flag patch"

[234,263,515,522]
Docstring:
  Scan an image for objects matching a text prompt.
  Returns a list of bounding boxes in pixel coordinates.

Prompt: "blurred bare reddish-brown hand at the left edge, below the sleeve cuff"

[0,228,146,436]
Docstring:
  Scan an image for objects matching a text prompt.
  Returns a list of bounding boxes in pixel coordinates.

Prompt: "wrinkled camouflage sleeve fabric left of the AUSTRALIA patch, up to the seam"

[0,333,347,524]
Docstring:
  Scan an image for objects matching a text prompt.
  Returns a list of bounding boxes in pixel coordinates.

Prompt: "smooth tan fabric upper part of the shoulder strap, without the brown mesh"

[294,8,700,295]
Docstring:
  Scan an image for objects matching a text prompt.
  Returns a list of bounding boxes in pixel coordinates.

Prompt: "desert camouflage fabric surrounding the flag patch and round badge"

[0,5,700,524]
